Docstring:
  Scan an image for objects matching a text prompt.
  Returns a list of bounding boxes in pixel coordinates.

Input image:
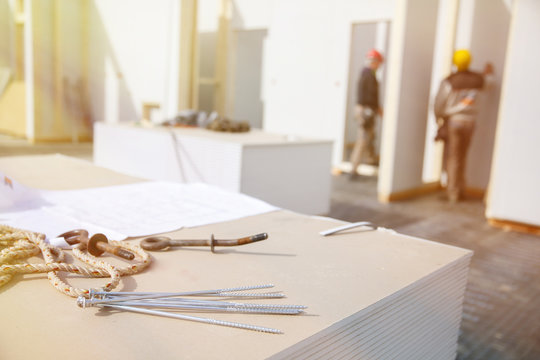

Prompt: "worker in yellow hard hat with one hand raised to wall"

[434,49,493,202]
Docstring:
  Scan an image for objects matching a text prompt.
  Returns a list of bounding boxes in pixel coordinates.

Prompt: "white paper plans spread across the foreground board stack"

[0,173,277,240]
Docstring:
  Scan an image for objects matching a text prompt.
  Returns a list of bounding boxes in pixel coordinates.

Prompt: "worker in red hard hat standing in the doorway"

[350,49,384,179]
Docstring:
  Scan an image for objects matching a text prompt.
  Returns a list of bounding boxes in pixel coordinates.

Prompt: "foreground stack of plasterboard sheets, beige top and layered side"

[0,155,472,360]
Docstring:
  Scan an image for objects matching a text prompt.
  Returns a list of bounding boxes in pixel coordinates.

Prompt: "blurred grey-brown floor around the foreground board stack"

[0,135,540,360]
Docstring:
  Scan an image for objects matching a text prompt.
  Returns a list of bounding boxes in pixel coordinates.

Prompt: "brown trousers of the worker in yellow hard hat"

[445,118,474,201]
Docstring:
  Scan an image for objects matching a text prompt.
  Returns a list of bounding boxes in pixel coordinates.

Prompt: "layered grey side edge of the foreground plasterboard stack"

[272,235,472,359]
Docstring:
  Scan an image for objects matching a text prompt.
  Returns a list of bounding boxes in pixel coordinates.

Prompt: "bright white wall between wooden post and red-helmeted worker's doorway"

[232,0,394,163]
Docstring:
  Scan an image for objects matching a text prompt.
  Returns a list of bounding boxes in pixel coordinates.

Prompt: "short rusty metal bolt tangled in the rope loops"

[58,229,135,260]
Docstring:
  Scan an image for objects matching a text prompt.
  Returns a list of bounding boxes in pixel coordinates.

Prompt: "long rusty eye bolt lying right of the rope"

[140,233,268,252]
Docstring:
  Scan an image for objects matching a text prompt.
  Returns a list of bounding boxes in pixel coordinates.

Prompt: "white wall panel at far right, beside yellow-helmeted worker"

[486,0,540,226]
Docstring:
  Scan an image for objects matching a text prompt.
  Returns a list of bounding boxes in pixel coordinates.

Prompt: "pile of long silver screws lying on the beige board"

[77,284,306,334]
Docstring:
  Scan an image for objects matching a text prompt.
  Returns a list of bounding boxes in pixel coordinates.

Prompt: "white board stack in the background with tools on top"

[94,123,332,214]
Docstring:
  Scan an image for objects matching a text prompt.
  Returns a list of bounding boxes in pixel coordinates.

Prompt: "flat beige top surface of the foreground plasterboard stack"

[0,155,471,359]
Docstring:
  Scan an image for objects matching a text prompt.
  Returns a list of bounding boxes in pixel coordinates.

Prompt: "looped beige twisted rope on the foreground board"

[0,225,150,297]
